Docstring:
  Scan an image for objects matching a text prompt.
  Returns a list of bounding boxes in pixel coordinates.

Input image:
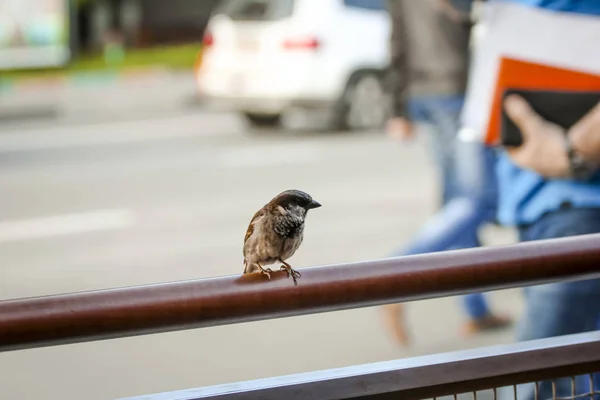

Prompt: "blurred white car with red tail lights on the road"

[196,0,391,130]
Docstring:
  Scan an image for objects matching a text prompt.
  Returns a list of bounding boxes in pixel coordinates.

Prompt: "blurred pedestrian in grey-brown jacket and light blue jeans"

[384,0,510,344]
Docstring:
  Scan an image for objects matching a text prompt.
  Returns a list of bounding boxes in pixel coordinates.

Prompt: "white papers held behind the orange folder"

[462,1,600,141]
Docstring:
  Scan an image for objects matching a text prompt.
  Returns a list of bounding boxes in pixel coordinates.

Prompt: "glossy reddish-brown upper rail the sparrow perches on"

[0,234,600,351]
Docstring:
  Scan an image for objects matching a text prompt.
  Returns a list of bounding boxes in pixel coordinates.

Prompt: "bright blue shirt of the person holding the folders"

[496,0,600,225]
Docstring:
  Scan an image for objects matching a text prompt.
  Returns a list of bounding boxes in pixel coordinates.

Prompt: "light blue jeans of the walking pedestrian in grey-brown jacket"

[395,96,497,319]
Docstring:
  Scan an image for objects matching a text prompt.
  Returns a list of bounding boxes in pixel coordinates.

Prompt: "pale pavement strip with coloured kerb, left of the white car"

[0,69,203,122]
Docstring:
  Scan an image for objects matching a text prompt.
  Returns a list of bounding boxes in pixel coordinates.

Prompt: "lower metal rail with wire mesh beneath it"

[118,331,600,400]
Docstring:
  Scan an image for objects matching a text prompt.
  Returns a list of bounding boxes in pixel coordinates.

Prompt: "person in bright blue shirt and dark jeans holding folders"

[469,0,600,400]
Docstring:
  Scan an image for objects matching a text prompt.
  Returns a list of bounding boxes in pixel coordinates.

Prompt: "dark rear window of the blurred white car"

[217,0,294,21]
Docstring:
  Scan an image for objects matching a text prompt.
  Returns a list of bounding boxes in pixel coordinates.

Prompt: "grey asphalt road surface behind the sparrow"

[0,112,521,400]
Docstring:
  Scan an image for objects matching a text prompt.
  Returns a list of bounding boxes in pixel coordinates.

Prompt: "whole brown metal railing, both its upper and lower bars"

[0,234,600,400]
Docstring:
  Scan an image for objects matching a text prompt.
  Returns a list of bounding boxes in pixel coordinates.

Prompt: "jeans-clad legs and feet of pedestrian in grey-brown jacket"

[383,96,510,345]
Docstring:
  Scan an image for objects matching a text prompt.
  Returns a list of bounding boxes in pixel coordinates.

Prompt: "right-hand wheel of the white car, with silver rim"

[338,73,389,130]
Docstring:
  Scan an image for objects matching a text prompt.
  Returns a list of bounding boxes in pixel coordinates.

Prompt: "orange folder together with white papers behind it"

[462,2,600,145]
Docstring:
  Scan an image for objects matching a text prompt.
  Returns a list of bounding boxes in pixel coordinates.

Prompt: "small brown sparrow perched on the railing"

[243,190,321,285]
